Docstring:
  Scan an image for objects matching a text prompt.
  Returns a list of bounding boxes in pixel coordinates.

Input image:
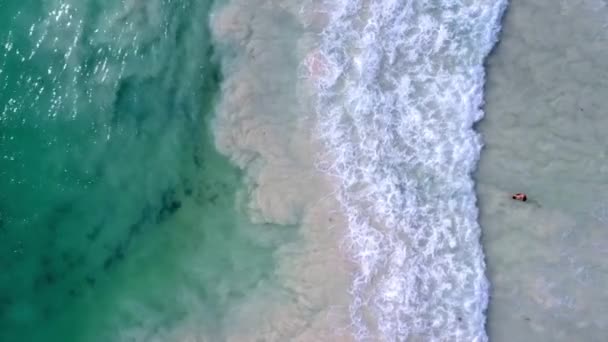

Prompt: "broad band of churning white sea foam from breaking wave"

[307,0,507,341]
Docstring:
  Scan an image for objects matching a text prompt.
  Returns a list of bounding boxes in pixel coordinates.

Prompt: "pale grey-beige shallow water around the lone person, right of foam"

[477,0,608,342]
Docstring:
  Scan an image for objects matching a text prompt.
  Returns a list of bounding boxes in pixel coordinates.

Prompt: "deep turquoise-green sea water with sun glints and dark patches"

[0,0,273,341]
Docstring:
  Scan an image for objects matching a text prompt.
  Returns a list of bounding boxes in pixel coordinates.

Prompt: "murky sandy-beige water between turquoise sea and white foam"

[212,0,351,341]
